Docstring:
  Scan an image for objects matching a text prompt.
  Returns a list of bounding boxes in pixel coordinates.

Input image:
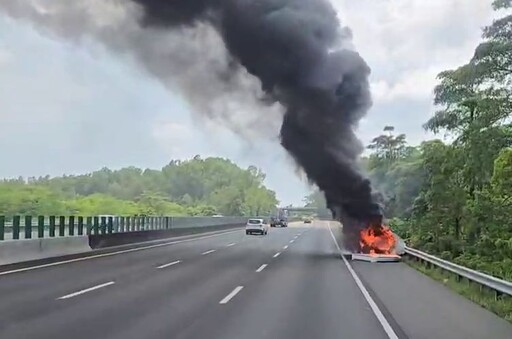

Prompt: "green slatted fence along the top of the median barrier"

[0,216,252,241]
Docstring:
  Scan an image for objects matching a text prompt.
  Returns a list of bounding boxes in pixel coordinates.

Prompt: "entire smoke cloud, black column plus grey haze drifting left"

[0,0,380,247]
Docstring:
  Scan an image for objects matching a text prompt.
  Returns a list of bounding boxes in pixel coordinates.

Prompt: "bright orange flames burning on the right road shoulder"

[359,225,396,254]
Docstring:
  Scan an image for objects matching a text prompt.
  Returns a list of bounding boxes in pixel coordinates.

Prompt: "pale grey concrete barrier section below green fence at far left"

[0,236,91,265]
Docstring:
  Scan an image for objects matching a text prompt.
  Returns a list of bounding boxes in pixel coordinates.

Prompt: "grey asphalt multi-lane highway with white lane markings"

[0,222,512,339]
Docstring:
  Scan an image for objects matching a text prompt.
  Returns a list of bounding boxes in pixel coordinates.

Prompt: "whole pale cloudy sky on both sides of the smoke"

[0,0,502,205]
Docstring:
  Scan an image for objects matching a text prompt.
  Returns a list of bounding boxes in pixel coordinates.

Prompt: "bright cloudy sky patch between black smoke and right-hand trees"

[332,0,496,143]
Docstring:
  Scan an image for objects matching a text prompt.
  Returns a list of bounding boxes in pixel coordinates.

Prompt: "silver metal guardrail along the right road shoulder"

[405,247,512,297]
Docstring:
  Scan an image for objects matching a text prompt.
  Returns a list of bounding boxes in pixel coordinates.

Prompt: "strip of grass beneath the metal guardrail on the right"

[406,260,512,323]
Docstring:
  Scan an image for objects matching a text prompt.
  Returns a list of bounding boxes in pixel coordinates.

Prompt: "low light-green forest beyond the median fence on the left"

[0,156,278,216]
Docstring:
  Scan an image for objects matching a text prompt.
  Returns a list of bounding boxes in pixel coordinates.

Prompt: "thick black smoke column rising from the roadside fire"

[129,0,380,235]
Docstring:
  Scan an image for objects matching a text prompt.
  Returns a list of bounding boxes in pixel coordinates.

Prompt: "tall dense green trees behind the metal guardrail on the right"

[363,0,512,280]
